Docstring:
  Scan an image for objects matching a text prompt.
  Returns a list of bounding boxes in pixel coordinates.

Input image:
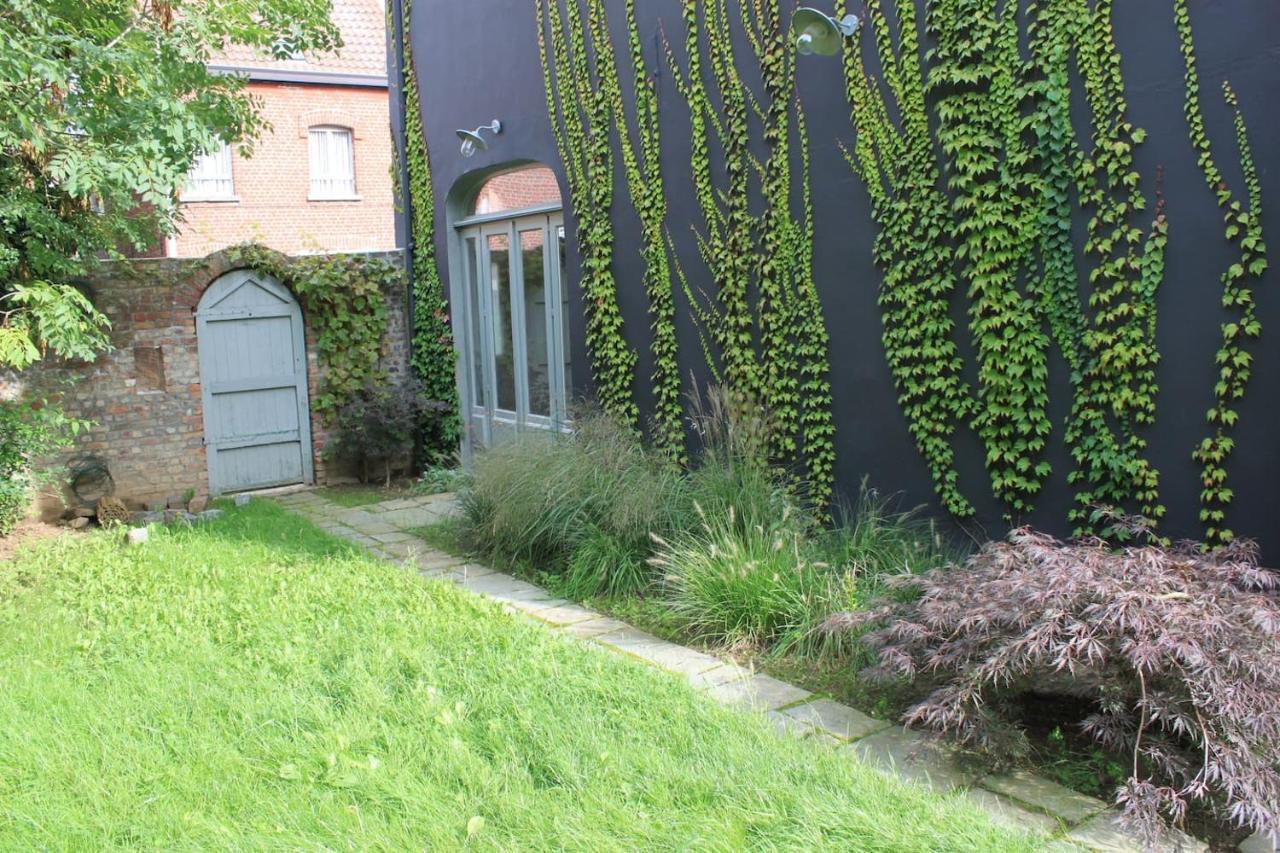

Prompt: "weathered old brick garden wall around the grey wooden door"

[0,245,408,514]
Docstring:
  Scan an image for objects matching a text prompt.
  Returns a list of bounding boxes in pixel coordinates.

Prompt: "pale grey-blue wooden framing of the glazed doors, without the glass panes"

[449,205,570,465]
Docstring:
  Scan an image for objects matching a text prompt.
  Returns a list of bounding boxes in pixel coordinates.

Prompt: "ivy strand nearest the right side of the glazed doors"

[536,0,640,425]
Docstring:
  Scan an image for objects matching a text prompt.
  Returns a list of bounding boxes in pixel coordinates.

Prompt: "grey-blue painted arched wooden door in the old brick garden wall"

[196,270,314,494]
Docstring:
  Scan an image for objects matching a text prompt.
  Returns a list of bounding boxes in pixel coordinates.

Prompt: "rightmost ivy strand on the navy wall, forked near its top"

[1174,0,1267,546]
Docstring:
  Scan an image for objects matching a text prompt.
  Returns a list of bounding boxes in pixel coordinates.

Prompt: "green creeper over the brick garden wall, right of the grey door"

[228,245,394,424]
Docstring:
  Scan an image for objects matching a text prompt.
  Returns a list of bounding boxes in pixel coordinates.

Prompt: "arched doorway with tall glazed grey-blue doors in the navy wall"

[451,164,572,452]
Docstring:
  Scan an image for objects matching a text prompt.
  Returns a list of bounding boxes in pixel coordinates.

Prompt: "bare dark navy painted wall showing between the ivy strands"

[411,0,1280,562]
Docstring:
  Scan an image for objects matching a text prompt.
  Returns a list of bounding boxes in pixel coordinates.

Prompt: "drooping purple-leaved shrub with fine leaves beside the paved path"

[827,521,1280,848]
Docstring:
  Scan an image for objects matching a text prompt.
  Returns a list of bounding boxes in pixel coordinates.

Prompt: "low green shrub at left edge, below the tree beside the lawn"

[0,400,88,537]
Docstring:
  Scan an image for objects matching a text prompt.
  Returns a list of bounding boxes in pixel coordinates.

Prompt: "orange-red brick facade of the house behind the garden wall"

[168,82,396,257]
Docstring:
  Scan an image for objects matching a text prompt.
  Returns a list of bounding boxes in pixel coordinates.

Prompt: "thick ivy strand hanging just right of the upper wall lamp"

[836,0,973,517]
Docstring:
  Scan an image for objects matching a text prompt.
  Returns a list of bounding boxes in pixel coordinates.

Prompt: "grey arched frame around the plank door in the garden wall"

[196,269,315,494]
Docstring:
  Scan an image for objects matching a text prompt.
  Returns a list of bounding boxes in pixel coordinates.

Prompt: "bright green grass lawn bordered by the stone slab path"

[0,502,1032,850]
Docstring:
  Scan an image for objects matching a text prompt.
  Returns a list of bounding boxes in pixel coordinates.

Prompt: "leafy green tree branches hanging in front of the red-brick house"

[0,0,340,368]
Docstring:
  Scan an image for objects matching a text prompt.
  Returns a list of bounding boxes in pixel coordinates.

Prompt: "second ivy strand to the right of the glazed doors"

[581,0,685,461]
